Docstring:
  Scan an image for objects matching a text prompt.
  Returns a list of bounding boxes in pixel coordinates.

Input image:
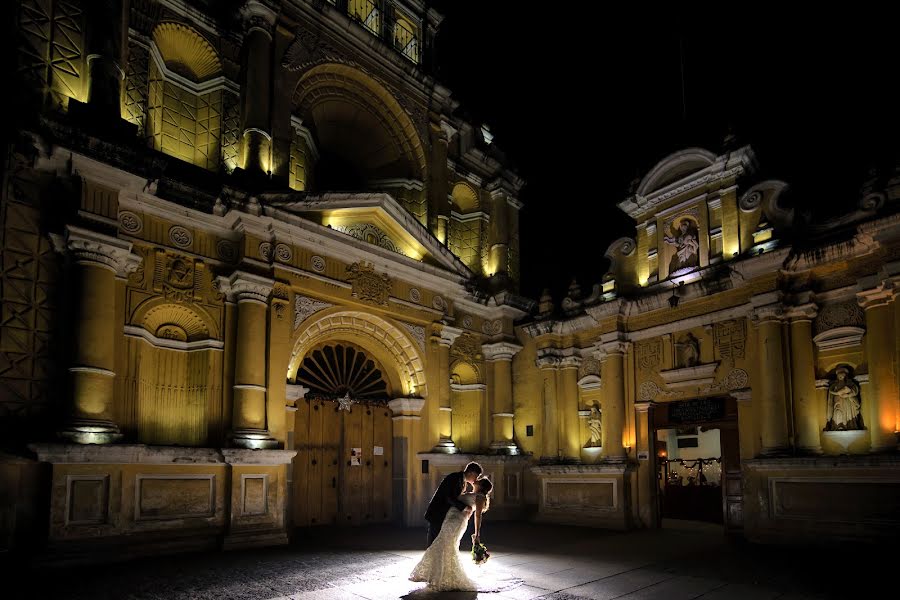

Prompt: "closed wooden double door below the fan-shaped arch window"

[292,399,393,527]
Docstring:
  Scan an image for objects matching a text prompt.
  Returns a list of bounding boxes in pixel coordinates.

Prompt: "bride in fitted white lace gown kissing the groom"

[409,477,494,592]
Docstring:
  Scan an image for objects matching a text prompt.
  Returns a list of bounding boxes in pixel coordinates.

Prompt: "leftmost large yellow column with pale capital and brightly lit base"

[54,225,141,444]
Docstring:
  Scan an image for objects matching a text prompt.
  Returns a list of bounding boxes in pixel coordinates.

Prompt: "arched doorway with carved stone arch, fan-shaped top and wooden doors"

[288,309,425,527]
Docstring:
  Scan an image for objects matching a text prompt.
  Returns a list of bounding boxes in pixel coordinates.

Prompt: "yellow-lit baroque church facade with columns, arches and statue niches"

[0,0,900,558]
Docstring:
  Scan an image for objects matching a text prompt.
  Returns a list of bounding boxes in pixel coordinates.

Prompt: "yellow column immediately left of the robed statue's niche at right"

[787,304,822,454]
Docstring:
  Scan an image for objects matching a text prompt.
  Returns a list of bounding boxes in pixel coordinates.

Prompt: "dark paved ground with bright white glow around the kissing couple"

[10,523,896,600]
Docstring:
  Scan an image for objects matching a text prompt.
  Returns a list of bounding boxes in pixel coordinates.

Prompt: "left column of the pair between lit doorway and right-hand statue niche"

[753,294,789,456]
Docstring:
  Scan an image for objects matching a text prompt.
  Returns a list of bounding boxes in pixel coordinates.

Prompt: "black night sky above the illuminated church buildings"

[431,0,900,301]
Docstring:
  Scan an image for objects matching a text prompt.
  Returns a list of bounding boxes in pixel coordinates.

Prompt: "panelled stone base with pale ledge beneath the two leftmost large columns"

[30,444,295,563]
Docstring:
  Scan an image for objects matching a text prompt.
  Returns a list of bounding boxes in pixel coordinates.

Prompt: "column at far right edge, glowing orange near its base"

[856,281,900,452]
